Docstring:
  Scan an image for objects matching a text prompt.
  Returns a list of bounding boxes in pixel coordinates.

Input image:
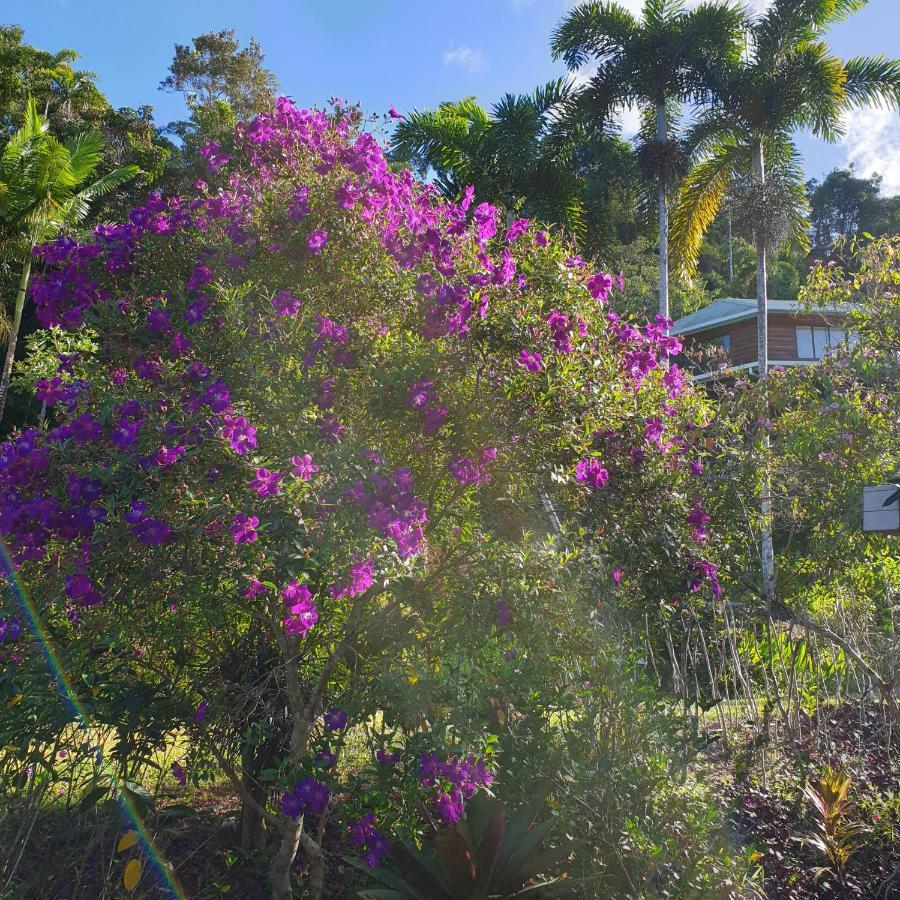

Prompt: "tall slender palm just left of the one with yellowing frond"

[551,0,744,318]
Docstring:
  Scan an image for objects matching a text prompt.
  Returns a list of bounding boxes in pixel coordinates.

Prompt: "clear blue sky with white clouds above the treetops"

[7,0,900,194]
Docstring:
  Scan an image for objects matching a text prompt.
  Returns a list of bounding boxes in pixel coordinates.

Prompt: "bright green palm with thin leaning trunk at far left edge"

[0,97,140,428]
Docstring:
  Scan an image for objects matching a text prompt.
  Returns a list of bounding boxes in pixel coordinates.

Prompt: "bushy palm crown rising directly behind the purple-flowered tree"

[391,80,584,234]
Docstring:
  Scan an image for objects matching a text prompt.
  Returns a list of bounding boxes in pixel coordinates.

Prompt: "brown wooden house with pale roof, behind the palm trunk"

[671,297,853,381]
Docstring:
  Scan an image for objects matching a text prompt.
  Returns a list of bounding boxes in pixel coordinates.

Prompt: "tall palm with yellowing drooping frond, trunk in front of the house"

[671,0,900,377]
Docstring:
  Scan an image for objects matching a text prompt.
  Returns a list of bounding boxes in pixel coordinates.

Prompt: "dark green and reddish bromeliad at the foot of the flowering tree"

[349,794,571,900]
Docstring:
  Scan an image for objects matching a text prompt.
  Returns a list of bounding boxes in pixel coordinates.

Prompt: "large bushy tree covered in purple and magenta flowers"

[0,99,721,900]
